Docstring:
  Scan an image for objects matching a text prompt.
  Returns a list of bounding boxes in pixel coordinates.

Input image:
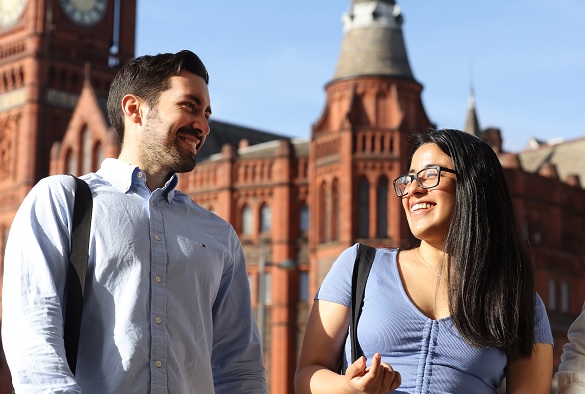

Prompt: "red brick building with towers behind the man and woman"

[0,0,585,394]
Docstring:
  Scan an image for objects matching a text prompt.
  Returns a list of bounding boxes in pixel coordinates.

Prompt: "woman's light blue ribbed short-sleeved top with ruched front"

[315,245,553,394]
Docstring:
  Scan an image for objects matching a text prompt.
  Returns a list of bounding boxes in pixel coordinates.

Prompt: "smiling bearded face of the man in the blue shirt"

[139,71,211,174]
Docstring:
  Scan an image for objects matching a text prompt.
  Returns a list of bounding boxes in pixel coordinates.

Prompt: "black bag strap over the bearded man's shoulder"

[63,175,93,375]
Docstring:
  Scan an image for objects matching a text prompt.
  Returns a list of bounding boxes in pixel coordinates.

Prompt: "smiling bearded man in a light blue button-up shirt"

[2,51,267,394]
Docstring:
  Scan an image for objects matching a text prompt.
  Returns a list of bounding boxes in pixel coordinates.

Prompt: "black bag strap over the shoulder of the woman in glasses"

[349,244,376,362]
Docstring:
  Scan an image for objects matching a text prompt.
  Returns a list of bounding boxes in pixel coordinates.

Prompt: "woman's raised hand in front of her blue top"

[345,353,401,394]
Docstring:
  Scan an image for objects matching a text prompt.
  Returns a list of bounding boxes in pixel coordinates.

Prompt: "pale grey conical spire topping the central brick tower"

[334,0,414,80]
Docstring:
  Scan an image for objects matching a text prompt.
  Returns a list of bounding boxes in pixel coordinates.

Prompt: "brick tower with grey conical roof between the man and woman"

[309,0,431,293]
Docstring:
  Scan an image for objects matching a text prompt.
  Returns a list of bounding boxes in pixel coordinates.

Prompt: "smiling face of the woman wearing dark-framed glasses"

[402,143,457,248]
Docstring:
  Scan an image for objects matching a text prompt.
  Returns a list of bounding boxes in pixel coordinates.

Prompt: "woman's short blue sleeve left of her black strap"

[315,244,358,307]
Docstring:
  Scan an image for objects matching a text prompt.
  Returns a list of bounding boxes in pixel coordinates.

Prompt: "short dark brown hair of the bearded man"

[108,50,209,144]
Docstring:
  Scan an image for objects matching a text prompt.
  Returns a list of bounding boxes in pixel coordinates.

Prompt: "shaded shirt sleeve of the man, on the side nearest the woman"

[211,226,268,394]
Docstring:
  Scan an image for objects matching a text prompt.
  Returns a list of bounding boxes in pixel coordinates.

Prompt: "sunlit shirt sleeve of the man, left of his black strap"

[2,176,80,393]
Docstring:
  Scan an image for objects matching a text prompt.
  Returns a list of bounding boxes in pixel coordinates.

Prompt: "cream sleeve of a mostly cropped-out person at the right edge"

[556,305,585,394]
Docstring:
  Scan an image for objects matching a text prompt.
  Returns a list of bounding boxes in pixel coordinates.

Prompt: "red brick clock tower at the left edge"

[0,0,136,336]
